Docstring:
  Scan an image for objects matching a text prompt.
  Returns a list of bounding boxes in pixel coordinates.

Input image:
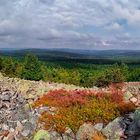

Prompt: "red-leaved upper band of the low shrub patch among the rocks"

[34,86,123,107]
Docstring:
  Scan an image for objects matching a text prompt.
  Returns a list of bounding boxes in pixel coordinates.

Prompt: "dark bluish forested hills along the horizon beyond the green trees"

[0,48,140,64]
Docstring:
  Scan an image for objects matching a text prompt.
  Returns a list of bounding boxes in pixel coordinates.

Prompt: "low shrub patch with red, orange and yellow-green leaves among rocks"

[34,87,134,133]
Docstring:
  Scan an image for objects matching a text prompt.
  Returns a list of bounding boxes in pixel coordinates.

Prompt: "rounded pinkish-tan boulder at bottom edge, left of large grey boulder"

[76,123,101,140]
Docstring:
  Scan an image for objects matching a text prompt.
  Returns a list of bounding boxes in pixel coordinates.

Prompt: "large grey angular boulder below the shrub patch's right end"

[102,117,126,140]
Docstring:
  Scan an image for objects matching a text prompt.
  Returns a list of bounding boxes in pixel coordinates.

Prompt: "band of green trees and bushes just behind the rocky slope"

[0,54,140,87]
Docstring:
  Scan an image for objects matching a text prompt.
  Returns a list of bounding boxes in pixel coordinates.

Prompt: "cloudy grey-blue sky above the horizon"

[0,0,140,50]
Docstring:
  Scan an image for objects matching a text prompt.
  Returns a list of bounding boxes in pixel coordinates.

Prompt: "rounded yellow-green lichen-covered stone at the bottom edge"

[33,130,51,140]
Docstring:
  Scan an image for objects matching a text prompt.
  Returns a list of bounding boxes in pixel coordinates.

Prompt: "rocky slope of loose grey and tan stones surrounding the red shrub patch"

[0,74,140,140]
